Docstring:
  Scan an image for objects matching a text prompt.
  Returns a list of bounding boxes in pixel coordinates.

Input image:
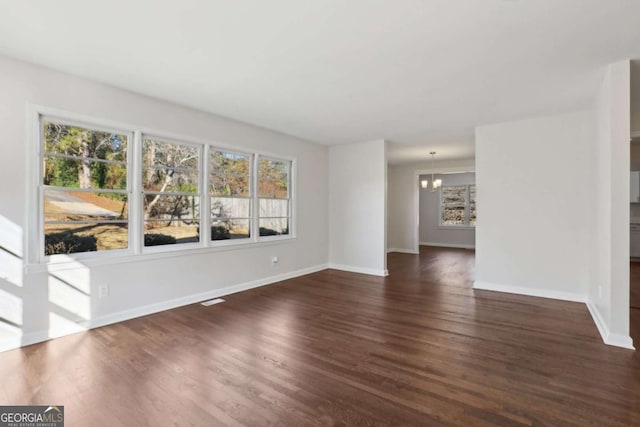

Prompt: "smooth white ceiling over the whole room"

[0,0,640,163]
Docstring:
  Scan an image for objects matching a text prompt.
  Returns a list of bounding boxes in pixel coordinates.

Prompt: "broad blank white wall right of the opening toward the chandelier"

[474,112,593,301]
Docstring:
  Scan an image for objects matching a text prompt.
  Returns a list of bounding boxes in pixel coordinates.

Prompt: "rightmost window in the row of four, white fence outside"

[258,158,291,236]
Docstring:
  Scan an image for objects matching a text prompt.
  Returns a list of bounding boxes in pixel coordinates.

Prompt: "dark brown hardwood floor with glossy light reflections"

[0,247,640,426]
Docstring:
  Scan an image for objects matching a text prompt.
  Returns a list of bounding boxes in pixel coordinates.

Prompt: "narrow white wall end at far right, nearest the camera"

[588,61,632,347]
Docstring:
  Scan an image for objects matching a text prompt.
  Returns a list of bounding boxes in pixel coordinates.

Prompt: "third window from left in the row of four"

[209,150,253,240]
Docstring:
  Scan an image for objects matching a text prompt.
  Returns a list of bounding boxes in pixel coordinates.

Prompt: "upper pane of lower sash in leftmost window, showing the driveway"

[44,190,129,222]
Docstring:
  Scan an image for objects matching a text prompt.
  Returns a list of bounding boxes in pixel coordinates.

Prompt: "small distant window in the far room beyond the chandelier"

[440,185,476,227]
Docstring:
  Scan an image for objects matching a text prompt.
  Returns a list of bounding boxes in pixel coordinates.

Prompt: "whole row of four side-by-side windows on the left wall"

[35,111,294,261]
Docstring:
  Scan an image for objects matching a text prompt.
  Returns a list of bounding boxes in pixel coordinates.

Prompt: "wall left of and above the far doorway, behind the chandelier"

[387,159,475,253]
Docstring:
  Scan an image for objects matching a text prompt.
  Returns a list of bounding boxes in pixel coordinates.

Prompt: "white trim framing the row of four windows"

[28,104,297,271]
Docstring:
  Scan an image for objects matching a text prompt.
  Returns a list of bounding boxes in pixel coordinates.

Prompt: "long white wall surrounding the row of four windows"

[0,57,330,350]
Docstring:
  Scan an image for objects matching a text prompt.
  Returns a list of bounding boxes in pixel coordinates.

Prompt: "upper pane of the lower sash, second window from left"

[144,194,200,223]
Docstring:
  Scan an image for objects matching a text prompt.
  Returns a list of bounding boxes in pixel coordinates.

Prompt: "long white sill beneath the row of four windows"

[24,236,296,274]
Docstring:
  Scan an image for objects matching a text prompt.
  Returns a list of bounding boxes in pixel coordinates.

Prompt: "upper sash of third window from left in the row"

[209,151,251,197]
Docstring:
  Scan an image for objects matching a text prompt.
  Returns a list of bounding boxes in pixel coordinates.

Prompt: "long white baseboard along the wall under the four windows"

[0,264,329,352]
